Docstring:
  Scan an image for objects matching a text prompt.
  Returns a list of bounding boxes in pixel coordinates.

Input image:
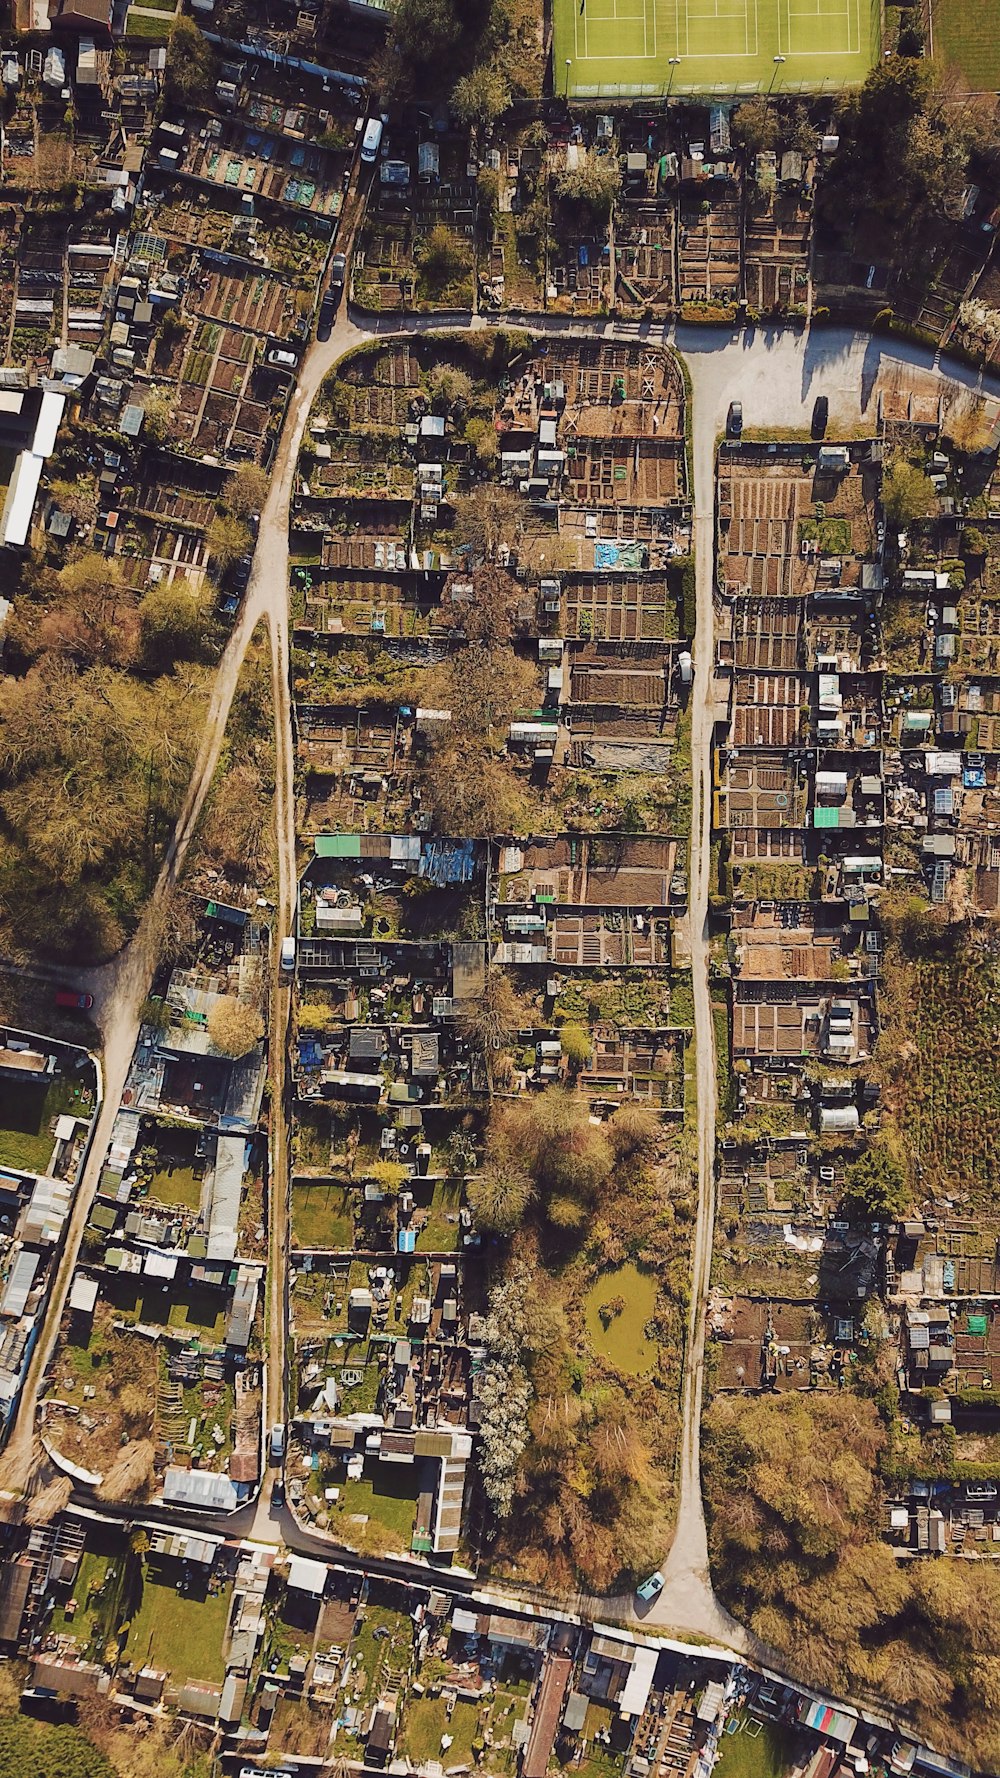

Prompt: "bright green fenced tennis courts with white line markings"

[553,0,875,98]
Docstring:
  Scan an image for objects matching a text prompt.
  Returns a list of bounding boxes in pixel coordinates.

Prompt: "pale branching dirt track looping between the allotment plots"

[4,273,1000,1652]
